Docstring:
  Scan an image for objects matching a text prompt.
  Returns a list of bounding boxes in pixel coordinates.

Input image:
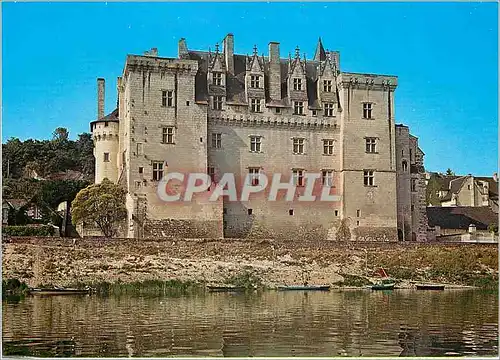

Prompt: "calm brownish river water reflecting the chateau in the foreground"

[2,290,498,357]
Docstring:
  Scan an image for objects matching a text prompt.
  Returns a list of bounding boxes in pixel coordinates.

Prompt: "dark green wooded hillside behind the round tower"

[2,128,94,180]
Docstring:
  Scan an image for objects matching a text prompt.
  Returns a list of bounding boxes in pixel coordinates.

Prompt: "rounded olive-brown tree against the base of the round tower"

[71,179,127,237]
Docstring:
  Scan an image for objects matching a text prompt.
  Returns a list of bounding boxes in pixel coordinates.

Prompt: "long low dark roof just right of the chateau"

[427,206,498,230]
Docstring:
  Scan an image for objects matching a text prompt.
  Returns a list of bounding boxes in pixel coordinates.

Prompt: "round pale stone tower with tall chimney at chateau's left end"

[90,78,119,184]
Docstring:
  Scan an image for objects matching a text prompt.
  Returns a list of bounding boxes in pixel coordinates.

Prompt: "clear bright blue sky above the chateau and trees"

[2,2,498,175]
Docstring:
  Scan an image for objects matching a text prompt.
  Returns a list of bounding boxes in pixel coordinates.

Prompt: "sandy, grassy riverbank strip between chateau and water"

[2,238,498,289]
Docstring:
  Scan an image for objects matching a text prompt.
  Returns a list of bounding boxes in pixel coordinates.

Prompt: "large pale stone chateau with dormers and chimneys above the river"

[91,34,427,241]
